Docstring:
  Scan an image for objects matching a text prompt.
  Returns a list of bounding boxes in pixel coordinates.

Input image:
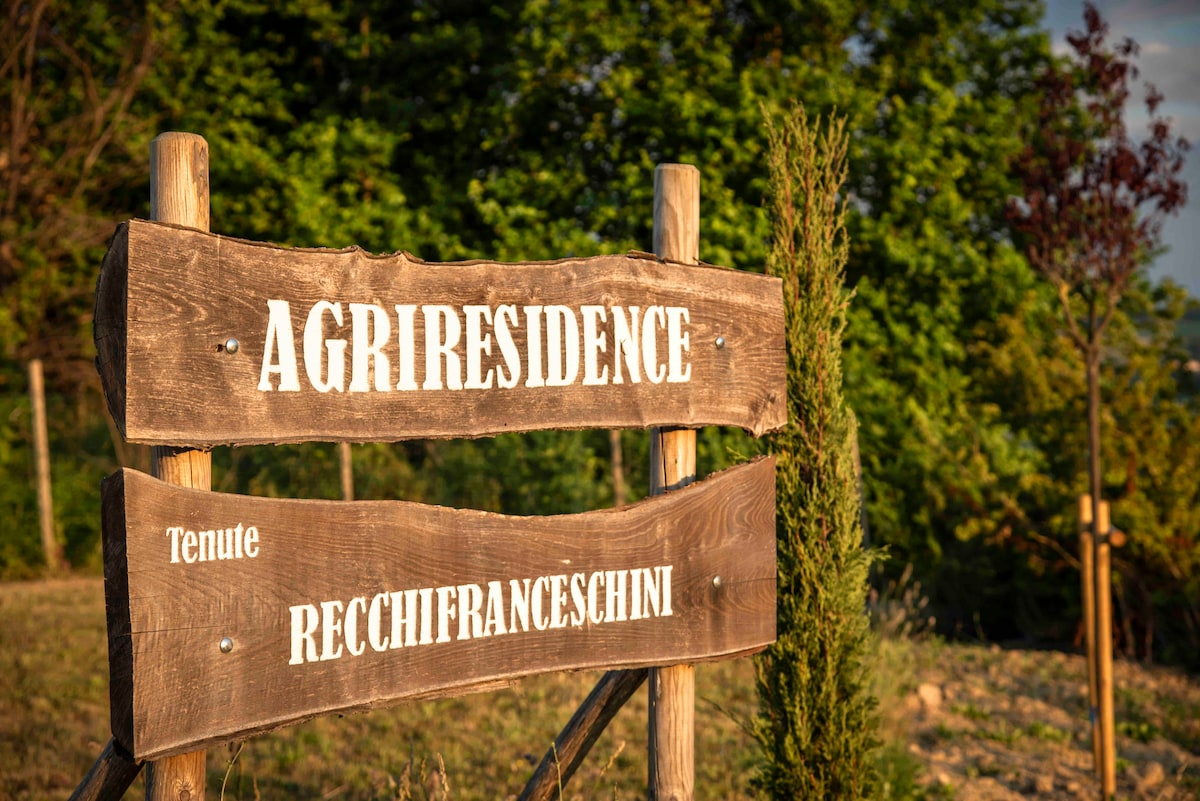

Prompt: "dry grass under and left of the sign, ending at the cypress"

[0,578,757,801]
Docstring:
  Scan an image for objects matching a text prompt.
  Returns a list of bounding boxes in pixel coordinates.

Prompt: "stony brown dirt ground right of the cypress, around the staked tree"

[899,643,1200,801]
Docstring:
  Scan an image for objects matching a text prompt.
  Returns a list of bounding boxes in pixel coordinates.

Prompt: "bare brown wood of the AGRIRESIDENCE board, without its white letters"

[95,221,786,447]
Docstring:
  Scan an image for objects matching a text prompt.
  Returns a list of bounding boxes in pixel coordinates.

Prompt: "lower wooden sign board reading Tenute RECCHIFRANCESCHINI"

[102,458,775,760]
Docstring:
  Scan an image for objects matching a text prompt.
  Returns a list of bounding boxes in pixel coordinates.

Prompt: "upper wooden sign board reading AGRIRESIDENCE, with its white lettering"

[95,221,786,447]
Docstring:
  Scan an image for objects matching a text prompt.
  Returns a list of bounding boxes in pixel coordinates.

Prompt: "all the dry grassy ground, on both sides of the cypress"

[11,578,1200,801]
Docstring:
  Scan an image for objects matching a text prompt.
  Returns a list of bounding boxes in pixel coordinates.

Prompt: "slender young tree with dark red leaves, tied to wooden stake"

[1009,4,1188,797]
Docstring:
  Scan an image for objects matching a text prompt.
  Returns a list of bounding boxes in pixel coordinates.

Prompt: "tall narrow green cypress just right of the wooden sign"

[754,108,877,799]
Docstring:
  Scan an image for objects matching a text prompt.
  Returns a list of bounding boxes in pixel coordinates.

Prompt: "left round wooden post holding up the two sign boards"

[145,133,216,801]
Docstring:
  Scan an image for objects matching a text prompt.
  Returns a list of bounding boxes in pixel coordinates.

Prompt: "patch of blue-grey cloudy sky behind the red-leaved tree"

[1045,0,1200,297]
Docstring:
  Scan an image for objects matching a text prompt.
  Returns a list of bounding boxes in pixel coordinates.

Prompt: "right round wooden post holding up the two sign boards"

[648,164,701,801]
